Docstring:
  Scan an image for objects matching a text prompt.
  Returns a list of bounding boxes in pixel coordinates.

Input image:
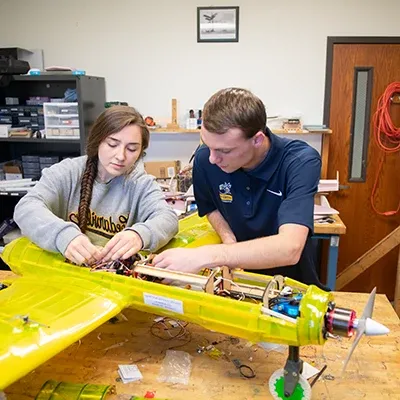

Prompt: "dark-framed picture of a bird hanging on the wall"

[197,6,239,43]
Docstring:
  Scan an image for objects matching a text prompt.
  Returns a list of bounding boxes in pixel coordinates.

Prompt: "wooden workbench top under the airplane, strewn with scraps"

[0,271,400,400]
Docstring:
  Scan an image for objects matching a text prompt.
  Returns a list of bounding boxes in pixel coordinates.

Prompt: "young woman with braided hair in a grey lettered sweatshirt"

[14,106,178,265]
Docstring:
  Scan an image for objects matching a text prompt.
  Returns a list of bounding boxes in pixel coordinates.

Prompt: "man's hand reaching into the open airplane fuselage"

[153,247,208,274]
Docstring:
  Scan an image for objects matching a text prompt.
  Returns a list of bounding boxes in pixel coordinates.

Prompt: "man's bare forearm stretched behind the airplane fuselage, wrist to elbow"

[203,234,303,270]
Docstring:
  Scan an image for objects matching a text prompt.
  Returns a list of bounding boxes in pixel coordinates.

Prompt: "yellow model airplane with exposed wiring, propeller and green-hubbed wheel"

[0,214,388,399]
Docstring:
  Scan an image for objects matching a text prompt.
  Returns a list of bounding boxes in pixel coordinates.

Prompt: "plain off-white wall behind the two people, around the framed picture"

[0,0,400,164]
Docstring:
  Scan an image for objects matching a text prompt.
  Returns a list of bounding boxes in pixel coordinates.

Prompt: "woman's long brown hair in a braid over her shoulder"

[78,106,150,233]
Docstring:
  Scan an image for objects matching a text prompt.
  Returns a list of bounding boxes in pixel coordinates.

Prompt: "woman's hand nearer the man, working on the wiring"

[100,229,143,262]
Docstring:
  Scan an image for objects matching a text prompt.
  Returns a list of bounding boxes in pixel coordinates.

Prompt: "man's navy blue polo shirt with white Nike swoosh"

[193,132,321,288]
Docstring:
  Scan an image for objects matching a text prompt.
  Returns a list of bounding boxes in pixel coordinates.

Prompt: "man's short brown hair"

[203,88,267,138]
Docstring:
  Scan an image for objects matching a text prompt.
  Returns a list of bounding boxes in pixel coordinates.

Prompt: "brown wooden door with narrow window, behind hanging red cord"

[327,44,400,299]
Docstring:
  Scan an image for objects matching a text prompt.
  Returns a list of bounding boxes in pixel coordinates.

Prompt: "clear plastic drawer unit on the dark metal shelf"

[43,103,80,139]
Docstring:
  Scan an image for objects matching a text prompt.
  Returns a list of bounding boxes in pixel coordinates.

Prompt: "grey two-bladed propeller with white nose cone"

[342,287,390,374]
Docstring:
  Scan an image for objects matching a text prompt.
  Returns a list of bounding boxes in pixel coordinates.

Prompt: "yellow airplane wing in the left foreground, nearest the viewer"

[0,247,125,390]
